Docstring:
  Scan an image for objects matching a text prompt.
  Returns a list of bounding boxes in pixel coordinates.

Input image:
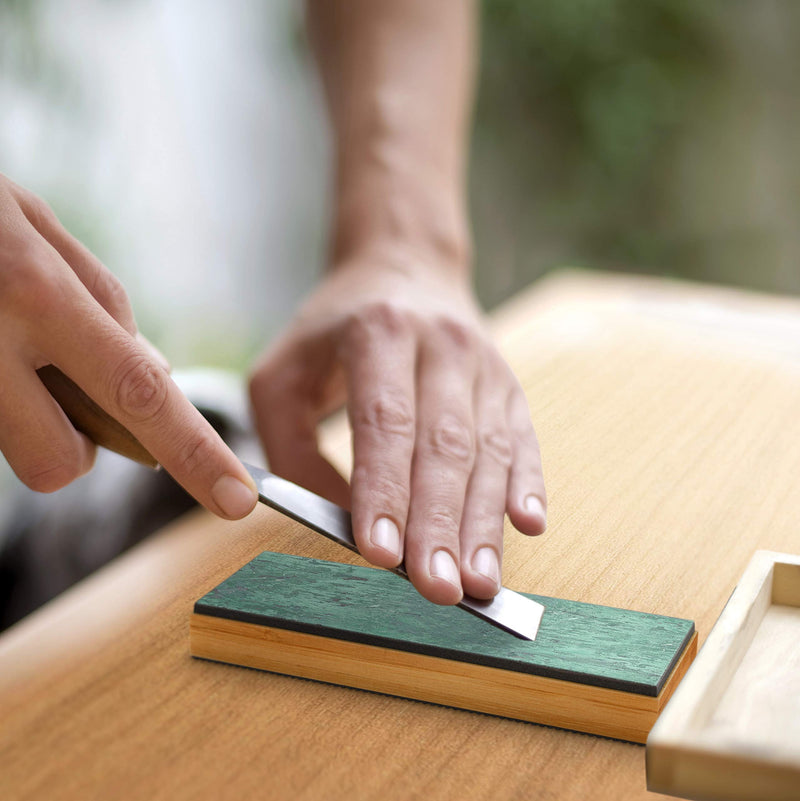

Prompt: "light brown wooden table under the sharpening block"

[0,272,800,801]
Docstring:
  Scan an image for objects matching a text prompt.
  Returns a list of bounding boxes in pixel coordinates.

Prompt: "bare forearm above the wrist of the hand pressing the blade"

[308,0,476,274]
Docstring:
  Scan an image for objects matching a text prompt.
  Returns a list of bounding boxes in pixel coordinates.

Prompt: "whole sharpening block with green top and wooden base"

[191,551,697,742]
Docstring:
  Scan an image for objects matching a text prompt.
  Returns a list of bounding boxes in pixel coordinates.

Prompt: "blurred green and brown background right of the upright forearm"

[472,0,800,304]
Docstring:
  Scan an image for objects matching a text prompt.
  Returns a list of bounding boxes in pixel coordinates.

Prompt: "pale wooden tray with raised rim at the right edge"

[647,551,800,801]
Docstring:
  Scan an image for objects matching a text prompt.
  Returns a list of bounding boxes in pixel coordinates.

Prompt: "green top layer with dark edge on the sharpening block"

[194,551,694,696]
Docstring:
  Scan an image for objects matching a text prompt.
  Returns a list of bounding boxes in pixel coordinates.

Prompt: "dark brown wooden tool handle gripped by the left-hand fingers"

[36,364,158,467]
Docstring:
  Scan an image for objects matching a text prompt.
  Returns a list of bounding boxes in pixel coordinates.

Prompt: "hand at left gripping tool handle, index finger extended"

[0,175,257,518]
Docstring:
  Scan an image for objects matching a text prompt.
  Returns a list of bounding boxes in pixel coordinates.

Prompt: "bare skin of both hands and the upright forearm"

[0,0,545,604]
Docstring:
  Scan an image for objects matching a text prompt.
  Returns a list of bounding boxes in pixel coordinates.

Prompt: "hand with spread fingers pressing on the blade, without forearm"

[251,256,545,604]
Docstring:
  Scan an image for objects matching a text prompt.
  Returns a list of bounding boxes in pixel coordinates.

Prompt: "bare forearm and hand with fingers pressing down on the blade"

[251,0,545,604]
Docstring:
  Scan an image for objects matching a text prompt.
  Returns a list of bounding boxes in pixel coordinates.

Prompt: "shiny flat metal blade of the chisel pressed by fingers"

[243,462,544,640]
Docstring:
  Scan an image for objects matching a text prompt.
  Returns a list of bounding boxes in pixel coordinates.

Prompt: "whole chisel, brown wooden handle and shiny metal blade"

[37,365,544,640]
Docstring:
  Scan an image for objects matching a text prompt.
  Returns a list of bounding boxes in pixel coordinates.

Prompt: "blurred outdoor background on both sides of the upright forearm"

[0,0,800,360]
